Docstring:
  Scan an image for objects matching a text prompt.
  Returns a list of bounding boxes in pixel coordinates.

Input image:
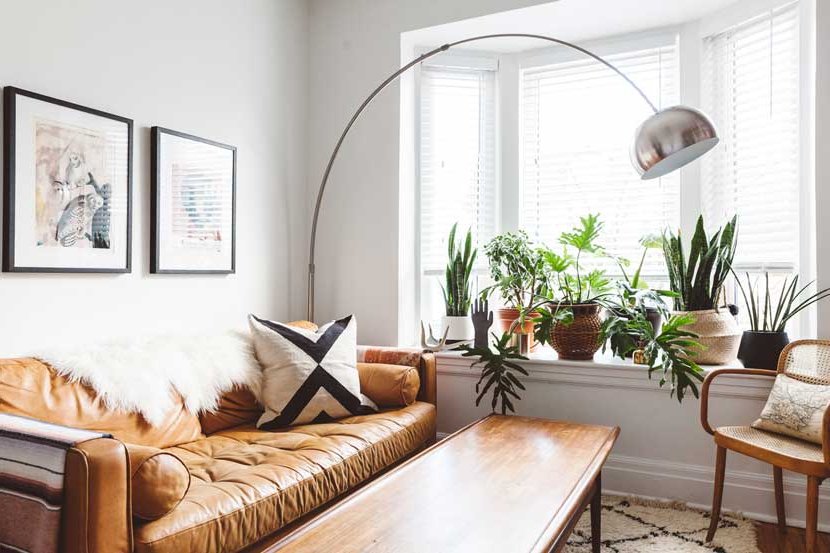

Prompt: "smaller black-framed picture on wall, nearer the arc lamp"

[150,127,236,274]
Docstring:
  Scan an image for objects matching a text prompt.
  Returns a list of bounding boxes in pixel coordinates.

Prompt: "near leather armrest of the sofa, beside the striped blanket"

[60,438,133,553]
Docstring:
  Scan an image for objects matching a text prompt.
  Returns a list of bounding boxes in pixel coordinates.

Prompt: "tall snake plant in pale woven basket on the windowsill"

[663,216,741,365]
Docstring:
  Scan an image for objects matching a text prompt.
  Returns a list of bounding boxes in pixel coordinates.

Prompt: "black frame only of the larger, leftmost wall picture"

[2,86,133,273]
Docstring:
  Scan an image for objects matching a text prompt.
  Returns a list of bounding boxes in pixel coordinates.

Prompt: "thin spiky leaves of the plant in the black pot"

[735,272,830,332]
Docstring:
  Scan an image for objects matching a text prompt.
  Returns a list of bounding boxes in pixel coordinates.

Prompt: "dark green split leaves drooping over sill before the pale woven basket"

[603,308,703,403]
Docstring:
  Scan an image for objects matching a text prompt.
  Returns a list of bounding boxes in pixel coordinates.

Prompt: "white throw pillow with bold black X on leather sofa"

[248,315,376,430]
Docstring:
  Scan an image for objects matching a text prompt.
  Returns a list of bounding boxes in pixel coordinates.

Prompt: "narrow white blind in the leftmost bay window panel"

[419,66,498,322]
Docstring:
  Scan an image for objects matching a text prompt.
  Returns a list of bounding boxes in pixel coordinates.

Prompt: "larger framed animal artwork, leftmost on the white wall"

[3,87,133,273]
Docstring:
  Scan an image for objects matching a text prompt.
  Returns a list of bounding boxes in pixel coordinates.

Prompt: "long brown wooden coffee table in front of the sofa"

[268,415,620,553]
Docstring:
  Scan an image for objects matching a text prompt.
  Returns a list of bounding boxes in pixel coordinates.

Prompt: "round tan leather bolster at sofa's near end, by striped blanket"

[124,444,190,521]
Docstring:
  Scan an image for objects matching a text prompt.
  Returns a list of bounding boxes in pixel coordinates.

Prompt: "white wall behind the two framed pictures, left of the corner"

[0,0,308,356]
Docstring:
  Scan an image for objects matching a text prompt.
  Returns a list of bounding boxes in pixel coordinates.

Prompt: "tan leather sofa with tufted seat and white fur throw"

[0,352,436,553]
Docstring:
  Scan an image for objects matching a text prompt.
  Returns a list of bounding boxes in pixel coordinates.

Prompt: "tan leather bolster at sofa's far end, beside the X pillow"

[357,363,421,407]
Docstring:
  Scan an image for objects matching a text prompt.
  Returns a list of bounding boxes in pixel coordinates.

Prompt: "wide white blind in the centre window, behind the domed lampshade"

[521,36,680,276]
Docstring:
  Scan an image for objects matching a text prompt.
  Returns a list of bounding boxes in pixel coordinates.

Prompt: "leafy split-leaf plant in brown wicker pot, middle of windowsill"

[537,214,610,361]
